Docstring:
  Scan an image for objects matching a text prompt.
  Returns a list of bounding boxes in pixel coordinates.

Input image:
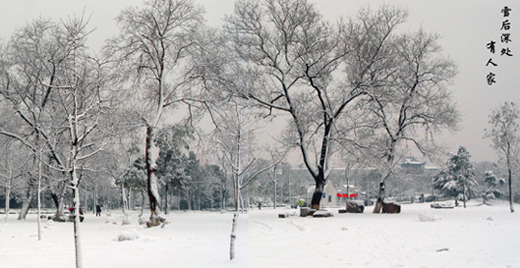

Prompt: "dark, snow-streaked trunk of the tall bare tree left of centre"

[145,126,160,226]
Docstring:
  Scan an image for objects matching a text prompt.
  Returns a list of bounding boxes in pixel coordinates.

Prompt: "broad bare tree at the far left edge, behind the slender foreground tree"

[0,19,68,219]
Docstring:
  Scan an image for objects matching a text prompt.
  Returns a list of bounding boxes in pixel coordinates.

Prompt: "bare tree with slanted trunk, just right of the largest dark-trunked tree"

[357,26,459,213]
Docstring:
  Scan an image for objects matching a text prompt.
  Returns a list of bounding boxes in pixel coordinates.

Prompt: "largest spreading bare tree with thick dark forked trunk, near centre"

[226,0,342,207]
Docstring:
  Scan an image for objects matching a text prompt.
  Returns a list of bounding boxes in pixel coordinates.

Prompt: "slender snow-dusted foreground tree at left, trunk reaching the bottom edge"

[52,17,114,267]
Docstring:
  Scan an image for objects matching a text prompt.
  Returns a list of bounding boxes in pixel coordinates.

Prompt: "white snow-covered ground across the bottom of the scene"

[0,202,520,268]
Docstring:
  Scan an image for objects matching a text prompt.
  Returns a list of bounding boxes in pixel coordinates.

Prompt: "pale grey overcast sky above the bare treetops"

[0,0,520,161]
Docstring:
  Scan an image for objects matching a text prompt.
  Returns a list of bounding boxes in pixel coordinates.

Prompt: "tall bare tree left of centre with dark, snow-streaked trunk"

[107,0,202,226]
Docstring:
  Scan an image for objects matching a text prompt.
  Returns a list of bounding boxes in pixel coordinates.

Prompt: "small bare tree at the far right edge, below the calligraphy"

[484,102,520,213]
